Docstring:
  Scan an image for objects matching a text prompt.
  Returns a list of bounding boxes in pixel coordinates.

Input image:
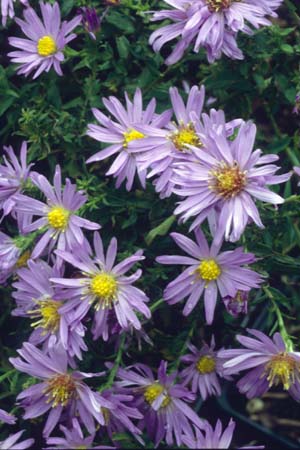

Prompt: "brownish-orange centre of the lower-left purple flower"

[43,374,76,408]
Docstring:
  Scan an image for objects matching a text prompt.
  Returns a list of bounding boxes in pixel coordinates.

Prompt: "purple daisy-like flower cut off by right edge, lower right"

[218,329,300,401]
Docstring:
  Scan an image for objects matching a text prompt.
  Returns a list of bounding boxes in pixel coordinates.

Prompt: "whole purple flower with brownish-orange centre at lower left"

[9,342,110,437]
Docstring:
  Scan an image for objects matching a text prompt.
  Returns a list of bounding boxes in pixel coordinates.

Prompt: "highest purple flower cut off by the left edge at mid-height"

[0,141,32,216]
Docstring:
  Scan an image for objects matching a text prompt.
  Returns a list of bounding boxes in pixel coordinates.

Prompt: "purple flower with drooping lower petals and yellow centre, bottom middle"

[116,361,202,446]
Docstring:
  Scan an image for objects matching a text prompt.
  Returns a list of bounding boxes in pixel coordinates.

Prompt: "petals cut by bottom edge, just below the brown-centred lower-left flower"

[46,418,115,450]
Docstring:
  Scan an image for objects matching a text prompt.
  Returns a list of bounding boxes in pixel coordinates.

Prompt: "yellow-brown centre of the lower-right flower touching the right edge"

[265,353,300,390]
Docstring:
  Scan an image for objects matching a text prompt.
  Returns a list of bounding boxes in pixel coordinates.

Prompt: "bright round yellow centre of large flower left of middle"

[90,272,118,309]
